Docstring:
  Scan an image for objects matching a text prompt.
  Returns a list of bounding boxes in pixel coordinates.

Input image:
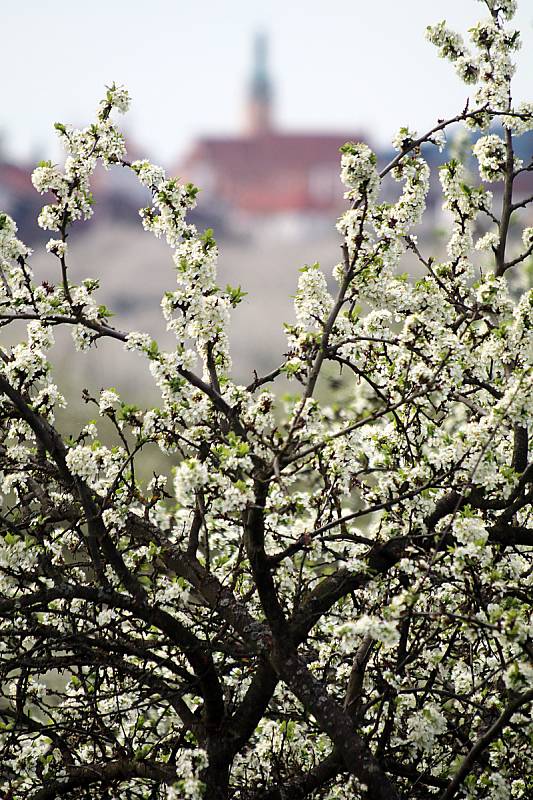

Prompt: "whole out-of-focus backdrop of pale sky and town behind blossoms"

[0,0,533,400]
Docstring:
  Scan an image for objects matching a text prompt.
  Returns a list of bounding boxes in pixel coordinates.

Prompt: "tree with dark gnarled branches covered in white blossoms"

[0,0,533,800]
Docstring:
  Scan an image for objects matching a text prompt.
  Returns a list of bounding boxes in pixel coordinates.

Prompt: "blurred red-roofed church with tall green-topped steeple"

[177,36,364,215]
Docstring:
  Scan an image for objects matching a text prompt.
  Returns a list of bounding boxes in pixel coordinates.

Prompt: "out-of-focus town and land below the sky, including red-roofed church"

[0,35,533,404]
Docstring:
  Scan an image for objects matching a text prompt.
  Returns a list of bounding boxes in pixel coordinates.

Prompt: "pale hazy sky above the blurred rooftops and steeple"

[0,0,533,164]
